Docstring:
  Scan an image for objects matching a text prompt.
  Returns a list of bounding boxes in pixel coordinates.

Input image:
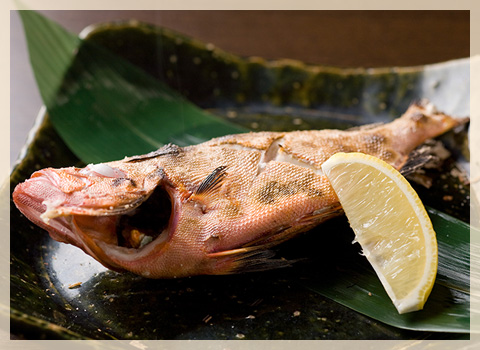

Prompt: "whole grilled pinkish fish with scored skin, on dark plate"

[13,103,461,278]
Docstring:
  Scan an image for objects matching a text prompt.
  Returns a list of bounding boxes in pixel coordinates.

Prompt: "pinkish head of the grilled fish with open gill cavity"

[12,153,204,277]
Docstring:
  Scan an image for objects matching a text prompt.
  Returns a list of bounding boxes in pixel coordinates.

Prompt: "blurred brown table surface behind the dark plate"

[10,11,470,166]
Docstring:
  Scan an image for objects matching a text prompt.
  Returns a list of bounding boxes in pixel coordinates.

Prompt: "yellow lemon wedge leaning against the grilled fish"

[322,153,438,314]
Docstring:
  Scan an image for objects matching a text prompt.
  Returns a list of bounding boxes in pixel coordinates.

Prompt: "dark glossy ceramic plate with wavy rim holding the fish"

[11,23,469,339]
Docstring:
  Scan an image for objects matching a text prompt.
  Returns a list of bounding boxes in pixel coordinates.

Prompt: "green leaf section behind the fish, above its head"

[21,11,247,163]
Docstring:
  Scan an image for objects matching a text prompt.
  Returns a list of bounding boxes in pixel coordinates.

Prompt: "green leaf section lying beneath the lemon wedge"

[304,208,470,333]
